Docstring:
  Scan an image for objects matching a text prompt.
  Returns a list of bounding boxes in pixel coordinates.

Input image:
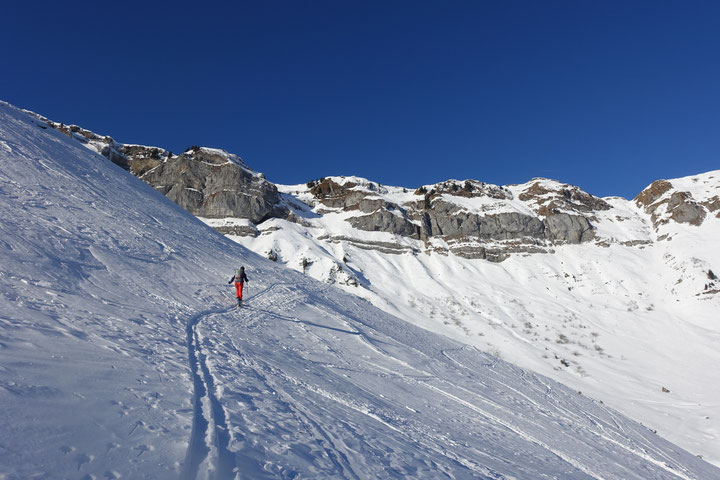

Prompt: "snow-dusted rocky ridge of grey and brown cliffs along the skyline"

[28,107,720,261]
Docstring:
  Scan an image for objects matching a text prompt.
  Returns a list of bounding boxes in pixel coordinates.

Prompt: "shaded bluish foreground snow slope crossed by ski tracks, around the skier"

[0,99,720,479]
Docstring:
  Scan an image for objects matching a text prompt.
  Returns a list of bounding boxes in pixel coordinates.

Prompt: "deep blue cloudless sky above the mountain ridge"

[5,0,720,198]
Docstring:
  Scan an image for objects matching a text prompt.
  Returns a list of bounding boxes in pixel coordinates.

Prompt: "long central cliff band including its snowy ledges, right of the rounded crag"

[292,177,611,261]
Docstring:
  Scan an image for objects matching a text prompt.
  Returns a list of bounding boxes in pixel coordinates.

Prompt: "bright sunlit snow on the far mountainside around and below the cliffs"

[232,171,720,465]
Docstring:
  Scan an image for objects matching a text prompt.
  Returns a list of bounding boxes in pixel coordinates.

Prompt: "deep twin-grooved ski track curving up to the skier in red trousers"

[180,307,236,480]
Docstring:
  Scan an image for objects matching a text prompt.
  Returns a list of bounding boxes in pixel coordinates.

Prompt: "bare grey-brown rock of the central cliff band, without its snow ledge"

[310,179,610,251]
